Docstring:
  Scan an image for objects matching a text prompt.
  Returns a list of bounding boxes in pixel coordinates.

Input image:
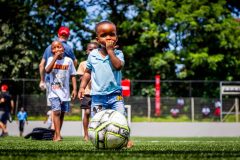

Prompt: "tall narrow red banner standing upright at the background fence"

[155,75,161,116]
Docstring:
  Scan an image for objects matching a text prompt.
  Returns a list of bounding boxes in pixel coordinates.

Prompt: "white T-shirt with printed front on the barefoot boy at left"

[46,57,76,101]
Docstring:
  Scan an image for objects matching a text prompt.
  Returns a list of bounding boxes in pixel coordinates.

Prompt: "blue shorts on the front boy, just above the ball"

[91,93,126,117]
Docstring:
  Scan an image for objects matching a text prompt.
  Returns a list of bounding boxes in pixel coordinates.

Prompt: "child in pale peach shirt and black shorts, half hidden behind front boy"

[77,42,98,141]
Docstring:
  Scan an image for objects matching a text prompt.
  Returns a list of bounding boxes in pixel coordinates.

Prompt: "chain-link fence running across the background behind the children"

[1,79,238,121]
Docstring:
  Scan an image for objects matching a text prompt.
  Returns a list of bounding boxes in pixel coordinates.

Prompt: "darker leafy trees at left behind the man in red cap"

[0,0,86,78]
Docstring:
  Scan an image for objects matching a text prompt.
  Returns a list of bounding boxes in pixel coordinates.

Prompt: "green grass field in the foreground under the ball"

[0,136,240,160]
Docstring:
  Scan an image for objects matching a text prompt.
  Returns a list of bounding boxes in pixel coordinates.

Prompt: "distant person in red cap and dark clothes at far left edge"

[0,84,14,136]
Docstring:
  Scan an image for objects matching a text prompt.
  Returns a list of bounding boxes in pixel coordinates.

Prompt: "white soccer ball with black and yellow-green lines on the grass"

[88,109,130,149]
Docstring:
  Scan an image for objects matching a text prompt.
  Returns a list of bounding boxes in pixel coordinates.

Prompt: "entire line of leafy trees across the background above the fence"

[0,0,240,96]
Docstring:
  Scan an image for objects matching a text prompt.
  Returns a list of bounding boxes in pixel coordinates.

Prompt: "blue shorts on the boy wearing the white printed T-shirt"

[49,97,70,112]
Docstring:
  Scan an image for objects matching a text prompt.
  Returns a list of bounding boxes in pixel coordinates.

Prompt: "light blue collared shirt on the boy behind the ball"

[87,49,124,95]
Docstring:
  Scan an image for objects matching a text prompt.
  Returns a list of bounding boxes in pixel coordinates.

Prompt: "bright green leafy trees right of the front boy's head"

[94,0,240,96]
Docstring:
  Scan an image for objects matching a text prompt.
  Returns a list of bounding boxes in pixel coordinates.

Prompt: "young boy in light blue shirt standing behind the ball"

[78,21,133,148]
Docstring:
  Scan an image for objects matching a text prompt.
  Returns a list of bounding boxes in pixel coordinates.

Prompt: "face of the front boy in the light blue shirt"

[96,23,118,47]
